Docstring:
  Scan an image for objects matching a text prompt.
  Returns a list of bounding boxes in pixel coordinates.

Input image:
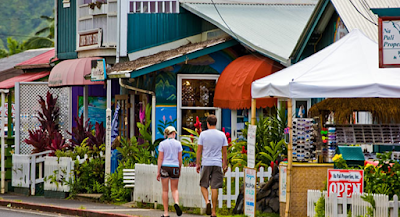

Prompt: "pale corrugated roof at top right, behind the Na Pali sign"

[331,0,400,42]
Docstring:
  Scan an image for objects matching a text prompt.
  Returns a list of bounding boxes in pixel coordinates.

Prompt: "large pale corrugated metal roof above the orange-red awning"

[182,3,315,64]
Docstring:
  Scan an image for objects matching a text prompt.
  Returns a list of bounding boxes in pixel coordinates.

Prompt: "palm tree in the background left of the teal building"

[25,15,54,50]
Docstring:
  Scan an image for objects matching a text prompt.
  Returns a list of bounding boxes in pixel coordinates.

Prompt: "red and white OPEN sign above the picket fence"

[328,170,364,198]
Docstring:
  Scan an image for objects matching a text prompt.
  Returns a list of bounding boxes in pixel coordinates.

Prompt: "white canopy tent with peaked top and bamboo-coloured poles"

[251,29,400,216]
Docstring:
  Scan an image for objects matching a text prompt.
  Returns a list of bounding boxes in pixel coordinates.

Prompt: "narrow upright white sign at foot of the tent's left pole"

[244,167,257,216]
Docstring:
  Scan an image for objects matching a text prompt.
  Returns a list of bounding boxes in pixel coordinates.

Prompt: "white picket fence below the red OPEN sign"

[307,190,399,217]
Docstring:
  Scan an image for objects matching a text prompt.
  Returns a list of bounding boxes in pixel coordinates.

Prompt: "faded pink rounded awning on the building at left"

[49,57,104,87]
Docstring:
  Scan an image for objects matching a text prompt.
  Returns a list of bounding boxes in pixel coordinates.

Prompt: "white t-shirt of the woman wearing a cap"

[158,139,182,167]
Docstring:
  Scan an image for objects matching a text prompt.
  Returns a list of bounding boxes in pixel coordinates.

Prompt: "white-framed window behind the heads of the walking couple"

[177,75,221,135]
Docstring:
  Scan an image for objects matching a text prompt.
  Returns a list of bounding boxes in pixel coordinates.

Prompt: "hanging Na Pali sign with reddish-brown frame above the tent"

[378,17,400,68]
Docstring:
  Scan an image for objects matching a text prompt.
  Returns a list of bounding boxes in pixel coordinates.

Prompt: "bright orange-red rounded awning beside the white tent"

[214,55,283,110]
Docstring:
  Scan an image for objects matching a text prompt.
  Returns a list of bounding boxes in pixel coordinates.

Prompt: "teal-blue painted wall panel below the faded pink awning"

[78,96,107,127]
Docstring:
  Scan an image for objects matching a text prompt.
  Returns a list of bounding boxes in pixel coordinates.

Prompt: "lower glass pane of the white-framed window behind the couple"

[181,109,215,135]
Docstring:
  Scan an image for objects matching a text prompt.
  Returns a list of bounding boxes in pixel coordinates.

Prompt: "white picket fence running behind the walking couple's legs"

[133,164,272,208]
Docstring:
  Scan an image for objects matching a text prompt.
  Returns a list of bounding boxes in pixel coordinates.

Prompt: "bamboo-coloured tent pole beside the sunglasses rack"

[285,98,293,217]
